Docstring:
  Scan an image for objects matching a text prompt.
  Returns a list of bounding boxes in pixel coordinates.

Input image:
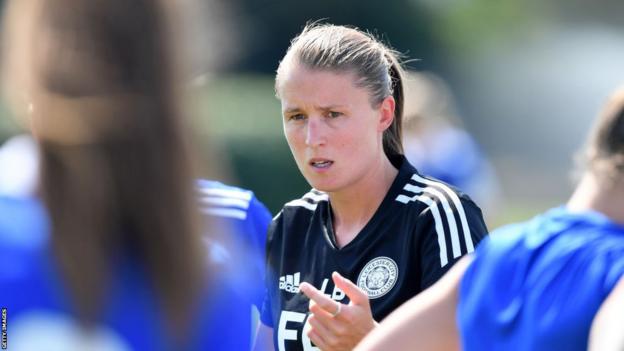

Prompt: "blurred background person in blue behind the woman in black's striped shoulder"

[403,71,501,220]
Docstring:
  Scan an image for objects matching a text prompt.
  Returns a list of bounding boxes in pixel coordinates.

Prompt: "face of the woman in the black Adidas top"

[278,64,394,192]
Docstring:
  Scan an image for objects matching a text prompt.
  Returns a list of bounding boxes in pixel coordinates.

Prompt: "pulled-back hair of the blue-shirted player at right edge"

[585,88,624,180]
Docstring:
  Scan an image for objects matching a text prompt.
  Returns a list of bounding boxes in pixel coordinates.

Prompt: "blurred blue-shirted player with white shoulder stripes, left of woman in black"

[197,179,271,350]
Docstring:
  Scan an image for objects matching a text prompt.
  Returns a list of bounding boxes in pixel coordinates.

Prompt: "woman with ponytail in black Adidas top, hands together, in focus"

[260,25,487,350]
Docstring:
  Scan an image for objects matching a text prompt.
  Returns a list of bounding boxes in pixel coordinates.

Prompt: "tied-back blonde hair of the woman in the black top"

[275,24,404,157]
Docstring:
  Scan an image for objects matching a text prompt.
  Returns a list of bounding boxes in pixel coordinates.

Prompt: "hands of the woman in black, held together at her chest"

[299,272,377,351]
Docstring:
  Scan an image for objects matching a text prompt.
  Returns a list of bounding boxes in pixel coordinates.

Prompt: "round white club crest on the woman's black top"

[357,256,399,299]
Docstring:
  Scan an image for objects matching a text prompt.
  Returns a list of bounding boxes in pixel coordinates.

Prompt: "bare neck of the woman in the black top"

[329,155,398,247]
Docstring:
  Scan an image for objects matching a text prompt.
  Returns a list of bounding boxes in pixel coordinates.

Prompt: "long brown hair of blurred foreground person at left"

[2,0,204,332]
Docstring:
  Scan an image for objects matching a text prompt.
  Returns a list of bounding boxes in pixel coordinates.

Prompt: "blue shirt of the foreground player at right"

[457,207,624,351]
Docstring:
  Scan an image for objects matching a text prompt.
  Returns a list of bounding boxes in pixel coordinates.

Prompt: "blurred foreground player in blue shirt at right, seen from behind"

[358,90,624,350]
